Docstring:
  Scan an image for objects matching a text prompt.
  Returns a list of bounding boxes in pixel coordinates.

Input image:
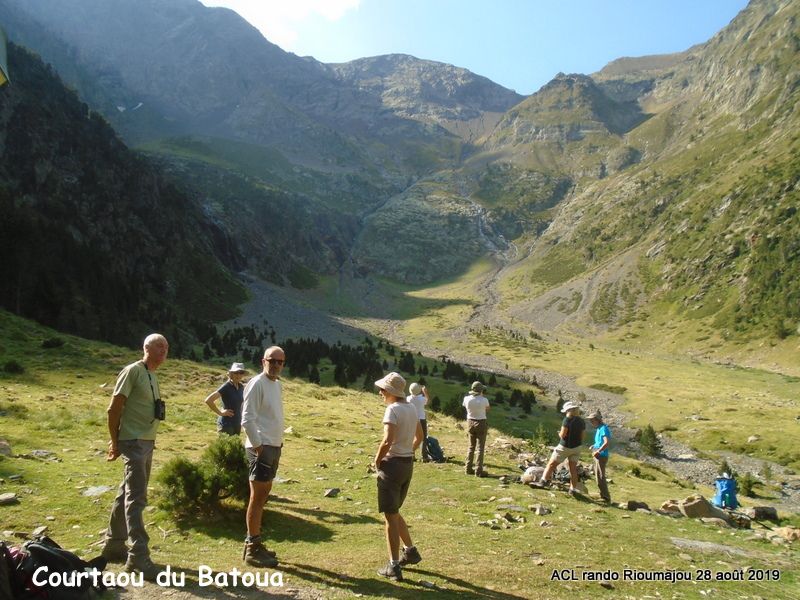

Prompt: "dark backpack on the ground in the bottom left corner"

[11,536,106,600]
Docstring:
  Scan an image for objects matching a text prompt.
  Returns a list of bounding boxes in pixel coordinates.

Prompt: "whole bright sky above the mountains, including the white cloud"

[201,0,747,94]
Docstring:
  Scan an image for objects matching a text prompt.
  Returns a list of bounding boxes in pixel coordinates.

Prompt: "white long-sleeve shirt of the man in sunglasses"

[242,373,283,448]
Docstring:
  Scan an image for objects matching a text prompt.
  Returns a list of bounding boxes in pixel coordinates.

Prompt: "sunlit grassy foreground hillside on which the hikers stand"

[0,313,800,599]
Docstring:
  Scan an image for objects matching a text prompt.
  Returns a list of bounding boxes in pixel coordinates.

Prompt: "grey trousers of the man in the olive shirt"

[106,440,155,560]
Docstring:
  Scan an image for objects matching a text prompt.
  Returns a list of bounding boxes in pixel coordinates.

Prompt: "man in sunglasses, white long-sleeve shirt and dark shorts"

[242,346,286,568]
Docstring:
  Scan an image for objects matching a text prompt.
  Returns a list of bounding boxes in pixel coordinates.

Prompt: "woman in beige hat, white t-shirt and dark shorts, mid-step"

[375,372,422,581]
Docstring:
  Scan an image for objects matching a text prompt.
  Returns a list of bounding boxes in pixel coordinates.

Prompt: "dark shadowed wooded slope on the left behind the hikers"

[0,44,244,352]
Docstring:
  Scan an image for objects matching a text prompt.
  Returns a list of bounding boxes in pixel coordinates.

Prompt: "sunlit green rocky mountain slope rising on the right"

[494,0,800,338]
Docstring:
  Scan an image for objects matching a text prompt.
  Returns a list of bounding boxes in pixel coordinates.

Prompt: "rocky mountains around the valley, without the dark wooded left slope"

[0,0,800,352]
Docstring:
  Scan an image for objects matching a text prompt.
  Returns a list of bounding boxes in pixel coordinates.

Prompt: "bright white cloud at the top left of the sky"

[201,0,361,51]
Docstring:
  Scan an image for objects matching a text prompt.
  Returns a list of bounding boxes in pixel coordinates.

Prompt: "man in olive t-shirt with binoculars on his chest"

[103,333,169,581]
